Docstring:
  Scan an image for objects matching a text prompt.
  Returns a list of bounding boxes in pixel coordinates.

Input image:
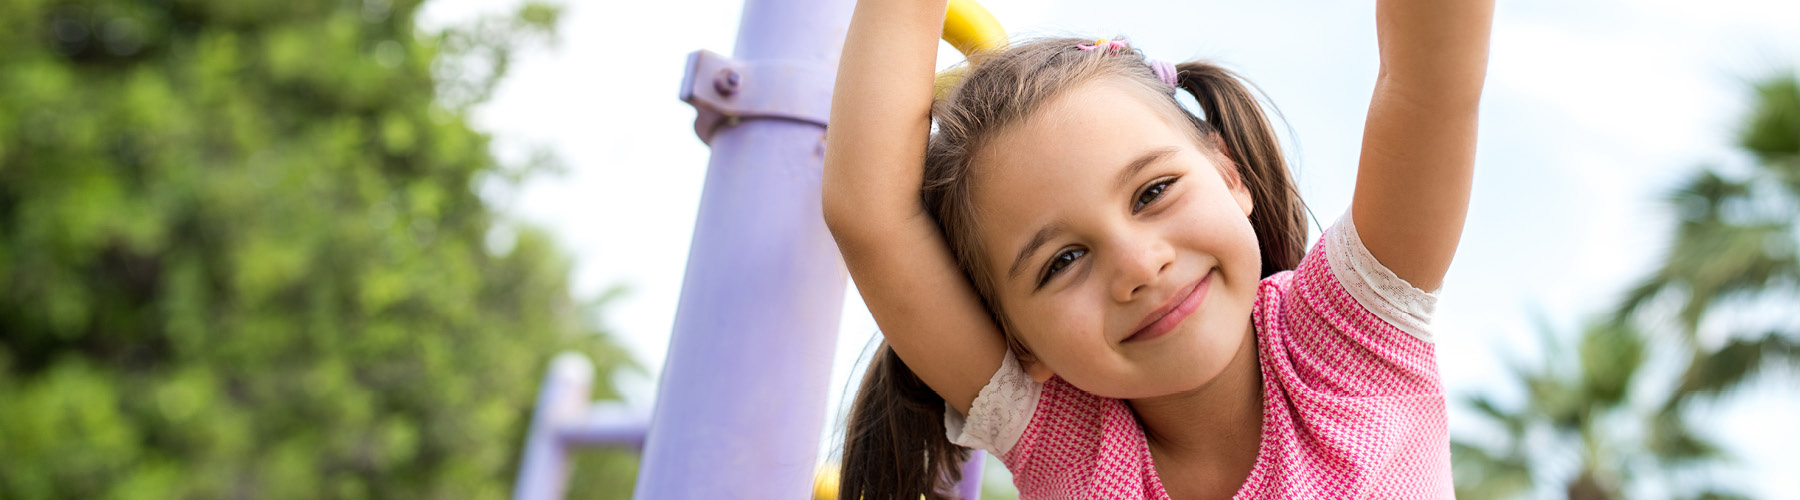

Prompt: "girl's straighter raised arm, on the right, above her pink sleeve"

[1350,0,1494,290]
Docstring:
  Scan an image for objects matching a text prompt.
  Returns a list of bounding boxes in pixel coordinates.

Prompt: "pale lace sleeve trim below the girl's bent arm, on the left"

[943,351,1044,457]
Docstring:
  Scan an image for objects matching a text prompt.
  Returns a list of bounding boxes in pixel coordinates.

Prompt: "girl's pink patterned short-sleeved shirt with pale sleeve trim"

[945,214,1454,500]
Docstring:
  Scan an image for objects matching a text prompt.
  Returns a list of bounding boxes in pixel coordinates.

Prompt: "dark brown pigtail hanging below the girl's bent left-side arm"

[837,340,968,500]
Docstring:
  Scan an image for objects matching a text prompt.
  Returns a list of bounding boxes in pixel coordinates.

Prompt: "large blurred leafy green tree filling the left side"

[0,0,635,500]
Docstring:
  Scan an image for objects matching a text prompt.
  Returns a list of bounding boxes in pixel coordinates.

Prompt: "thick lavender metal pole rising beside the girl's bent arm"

[635,0,853,500]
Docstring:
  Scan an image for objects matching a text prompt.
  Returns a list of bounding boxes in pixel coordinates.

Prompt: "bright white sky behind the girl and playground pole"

[425,0,1800,498]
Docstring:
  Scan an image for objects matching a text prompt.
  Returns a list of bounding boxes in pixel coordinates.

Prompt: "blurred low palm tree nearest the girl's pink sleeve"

[1451,320,1741,500]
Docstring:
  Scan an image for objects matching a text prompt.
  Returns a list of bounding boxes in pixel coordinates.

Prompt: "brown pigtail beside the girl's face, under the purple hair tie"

[1175,61,1307,277]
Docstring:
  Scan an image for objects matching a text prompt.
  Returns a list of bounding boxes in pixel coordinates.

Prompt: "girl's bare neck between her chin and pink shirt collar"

[1127,322,1262,471]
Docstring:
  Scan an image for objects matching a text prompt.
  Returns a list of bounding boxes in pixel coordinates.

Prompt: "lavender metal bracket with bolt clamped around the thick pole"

[680,50,837,144]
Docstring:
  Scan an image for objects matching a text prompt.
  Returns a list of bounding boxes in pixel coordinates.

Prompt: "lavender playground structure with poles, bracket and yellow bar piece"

[513,0,1006,500]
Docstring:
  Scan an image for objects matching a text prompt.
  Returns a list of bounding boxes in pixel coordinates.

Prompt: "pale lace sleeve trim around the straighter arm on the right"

[1325,210,1442,342]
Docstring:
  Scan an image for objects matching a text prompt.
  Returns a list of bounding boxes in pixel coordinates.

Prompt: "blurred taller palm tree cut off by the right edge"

[1615,76,1800,446]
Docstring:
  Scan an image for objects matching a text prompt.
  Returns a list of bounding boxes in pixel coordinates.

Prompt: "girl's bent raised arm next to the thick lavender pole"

[823,0,1006,414]
